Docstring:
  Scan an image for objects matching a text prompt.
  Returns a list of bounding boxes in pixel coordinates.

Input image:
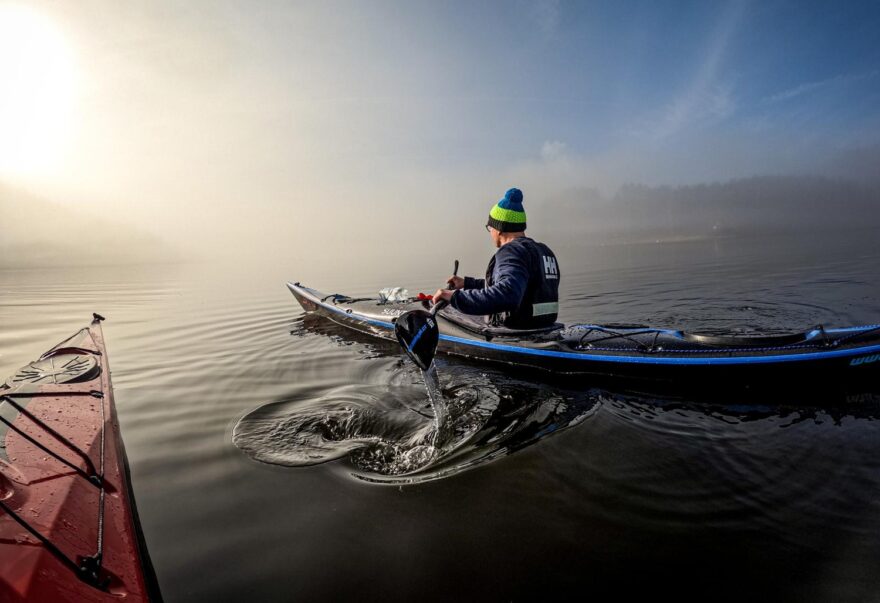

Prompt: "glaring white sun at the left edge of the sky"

[0,5,75,179]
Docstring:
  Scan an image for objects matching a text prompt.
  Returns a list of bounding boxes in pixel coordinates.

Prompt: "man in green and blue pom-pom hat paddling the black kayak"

[433,188,559,329]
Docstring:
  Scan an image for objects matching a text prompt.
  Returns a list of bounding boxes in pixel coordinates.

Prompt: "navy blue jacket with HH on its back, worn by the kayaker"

[450,237,558,328]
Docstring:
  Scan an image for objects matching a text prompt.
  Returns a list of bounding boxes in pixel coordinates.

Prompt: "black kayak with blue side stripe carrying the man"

[287,283,880,391]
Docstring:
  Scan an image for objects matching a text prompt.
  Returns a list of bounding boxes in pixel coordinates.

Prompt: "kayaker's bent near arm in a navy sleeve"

[450,247,529,316]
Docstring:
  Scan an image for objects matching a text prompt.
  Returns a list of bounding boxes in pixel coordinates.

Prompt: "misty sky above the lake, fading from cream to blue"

[0,1,880,276]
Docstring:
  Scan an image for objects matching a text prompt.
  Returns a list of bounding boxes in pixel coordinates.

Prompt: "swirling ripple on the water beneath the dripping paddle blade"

[233,370,598,484]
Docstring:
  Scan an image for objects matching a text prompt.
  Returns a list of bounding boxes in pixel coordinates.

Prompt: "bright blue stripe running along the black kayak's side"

[294,288,880,365]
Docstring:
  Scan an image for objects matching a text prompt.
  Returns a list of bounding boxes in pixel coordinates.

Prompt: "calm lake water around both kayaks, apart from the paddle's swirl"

[0,232,880,602]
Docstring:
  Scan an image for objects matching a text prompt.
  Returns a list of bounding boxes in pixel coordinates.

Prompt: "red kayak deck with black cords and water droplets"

[0,316,158,602]
